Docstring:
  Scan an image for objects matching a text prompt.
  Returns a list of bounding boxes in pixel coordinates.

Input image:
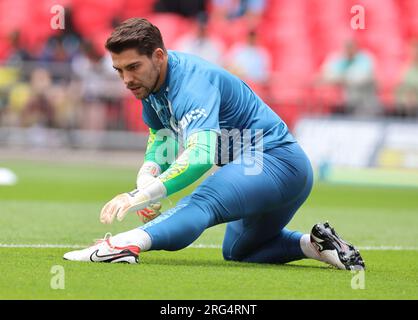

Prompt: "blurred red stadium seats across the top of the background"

[0,0,418,127]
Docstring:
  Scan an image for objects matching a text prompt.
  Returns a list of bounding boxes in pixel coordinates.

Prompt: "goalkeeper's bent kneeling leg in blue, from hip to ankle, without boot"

[222,144,313,263]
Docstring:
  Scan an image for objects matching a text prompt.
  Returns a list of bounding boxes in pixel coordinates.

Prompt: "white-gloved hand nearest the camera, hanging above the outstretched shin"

[100,189,151,224]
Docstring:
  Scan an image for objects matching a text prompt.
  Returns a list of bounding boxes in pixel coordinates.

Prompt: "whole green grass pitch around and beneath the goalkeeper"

[0,161,418,300]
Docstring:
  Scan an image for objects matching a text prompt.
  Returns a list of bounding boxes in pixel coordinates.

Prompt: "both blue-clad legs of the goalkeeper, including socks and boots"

[64,144,364,269]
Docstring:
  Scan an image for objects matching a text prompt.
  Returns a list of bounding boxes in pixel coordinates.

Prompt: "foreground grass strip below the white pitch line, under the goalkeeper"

[0,248,418,300]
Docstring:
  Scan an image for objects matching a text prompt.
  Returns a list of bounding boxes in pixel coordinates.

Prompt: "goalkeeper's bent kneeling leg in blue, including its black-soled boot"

[223,144,365,270]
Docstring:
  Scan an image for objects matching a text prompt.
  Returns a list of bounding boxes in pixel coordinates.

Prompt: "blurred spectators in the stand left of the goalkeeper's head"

[0,8,124,130]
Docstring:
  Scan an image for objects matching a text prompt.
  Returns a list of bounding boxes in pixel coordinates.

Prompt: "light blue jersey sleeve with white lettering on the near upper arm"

[174,79,221,144]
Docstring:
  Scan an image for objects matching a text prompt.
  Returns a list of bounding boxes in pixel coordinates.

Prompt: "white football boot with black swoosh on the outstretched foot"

[63,233,140,263]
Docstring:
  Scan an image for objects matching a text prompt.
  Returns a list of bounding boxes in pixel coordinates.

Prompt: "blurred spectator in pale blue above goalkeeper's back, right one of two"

[225,31,271,85]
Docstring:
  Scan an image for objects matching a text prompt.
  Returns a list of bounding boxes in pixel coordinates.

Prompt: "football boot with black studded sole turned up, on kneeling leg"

[311,222,366,270]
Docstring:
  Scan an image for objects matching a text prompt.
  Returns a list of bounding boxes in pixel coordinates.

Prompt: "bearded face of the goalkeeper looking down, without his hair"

[110,49,164,99]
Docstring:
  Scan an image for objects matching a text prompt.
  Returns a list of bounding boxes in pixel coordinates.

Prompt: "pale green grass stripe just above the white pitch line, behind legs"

[0,200,418,247]
